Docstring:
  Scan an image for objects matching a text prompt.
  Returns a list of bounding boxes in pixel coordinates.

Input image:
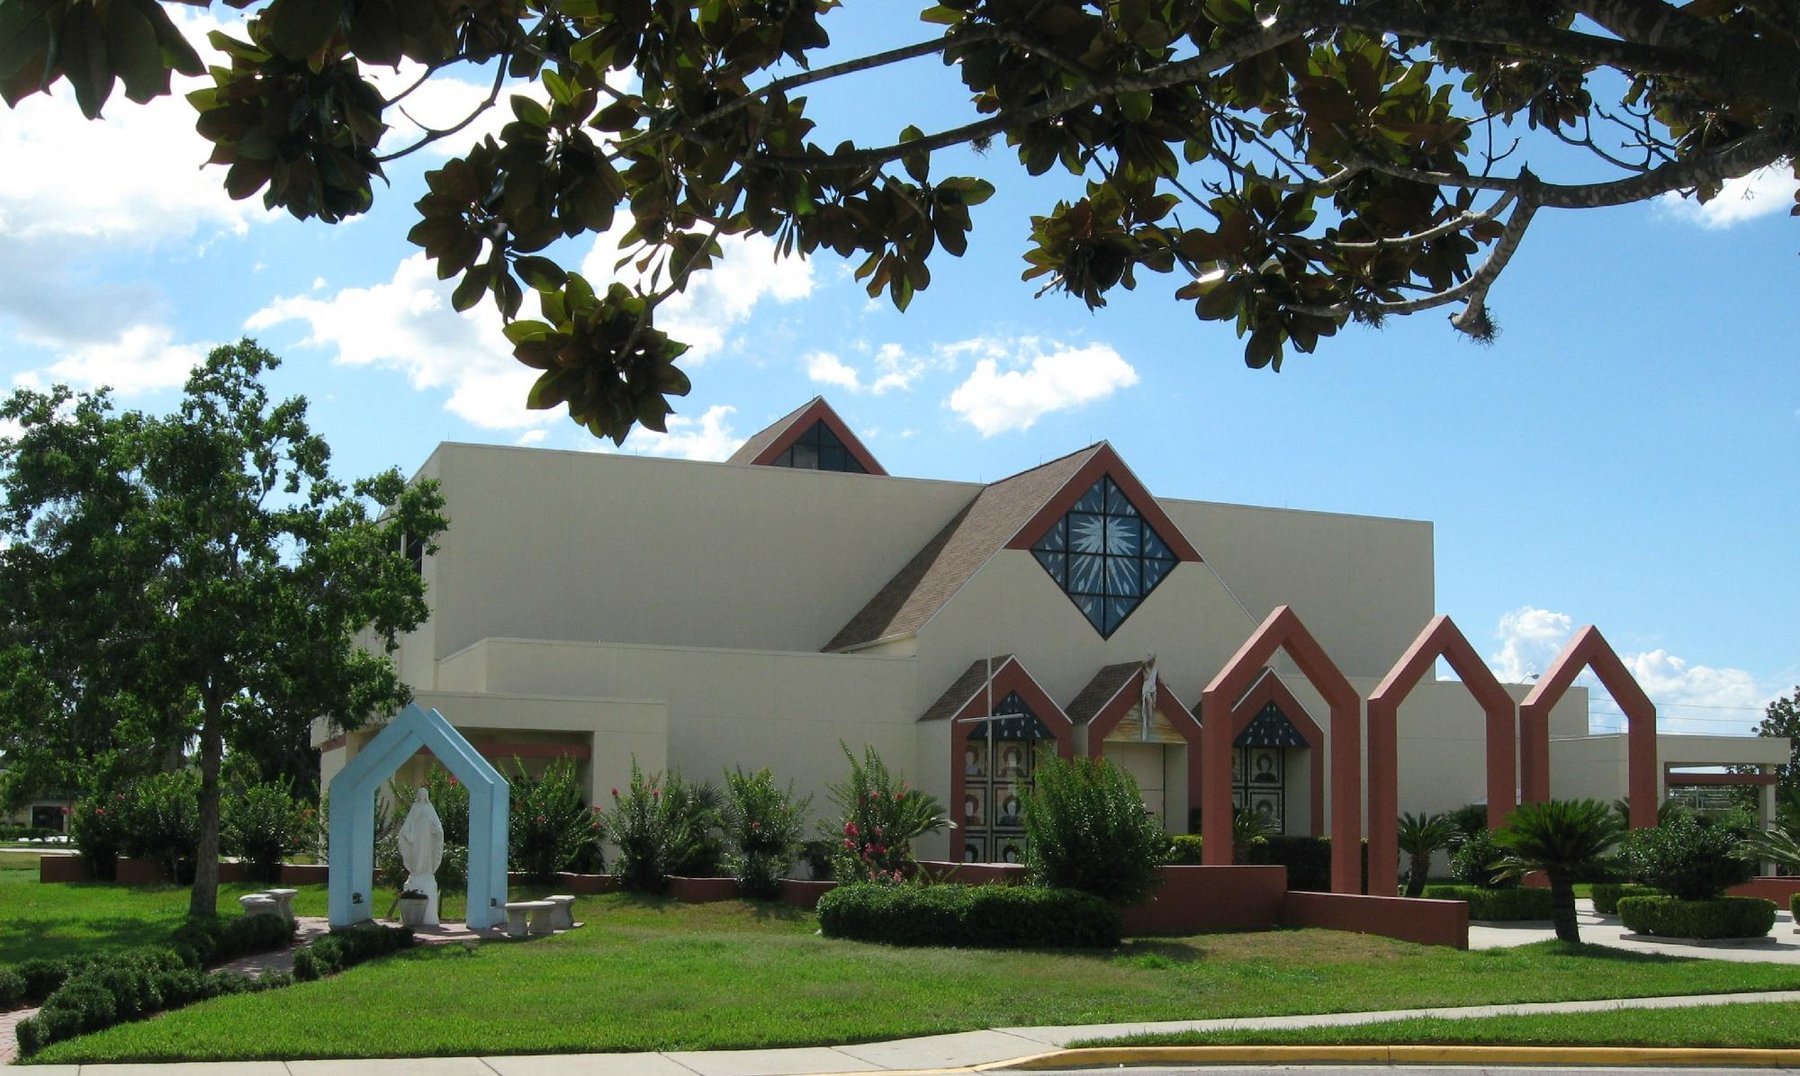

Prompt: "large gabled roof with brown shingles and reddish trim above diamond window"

[824,441,1201,651]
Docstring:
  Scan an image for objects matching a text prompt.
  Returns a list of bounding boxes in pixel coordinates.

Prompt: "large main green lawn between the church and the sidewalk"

[34,896,1800,1063]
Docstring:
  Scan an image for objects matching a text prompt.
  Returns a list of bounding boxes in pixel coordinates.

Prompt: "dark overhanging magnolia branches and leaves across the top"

[0,0,1800,441]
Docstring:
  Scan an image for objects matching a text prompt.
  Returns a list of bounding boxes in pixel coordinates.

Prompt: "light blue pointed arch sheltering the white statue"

[328,704,509,930]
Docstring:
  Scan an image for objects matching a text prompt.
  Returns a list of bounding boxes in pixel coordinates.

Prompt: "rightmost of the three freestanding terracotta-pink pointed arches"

[1519,624,1656,829]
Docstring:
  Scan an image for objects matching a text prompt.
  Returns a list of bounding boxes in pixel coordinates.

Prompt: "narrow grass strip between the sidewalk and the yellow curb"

[1075,1004,1800,1049]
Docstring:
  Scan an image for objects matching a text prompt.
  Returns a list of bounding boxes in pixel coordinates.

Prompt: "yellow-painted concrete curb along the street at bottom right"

[979,1045,1800,1076]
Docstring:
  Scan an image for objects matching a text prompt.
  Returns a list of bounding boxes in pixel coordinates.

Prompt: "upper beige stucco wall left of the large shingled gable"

[409,444,979,671]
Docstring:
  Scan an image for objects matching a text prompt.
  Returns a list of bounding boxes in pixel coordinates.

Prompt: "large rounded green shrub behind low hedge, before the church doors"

[1024,752,1172,903]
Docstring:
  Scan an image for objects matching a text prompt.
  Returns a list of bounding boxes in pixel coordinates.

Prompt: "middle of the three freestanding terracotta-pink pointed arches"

[1368,615,1517,894]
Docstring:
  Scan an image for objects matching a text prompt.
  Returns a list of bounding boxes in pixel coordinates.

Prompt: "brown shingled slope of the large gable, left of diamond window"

[824,444,1100,650]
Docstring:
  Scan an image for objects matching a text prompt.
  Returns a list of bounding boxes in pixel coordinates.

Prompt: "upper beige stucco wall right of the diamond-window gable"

[1161,500,1436,678]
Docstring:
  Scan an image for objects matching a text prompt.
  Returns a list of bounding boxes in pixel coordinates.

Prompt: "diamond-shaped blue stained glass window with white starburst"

[1031,477,1175,637]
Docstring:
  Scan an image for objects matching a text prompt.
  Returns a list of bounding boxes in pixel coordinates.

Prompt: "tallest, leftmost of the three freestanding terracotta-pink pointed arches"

[1201,605,1363,892]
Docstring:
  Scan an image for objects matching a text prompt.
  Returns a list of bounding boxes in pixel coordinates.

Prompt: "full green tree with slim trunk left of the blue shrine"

[0,340,445,914]
